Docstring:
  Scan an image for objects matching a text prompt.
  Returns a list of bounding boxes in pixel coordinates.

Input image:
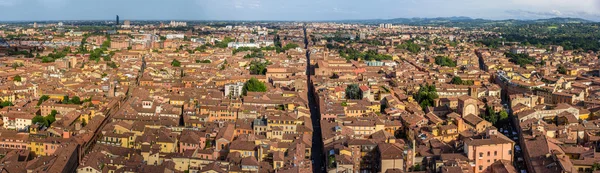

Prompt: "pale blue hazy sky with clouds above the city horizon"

[0,0,600,21]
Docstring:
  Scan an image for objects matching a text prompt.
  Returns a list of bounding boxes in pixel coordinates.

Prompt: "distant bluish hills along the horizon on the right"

[340,16,596,26]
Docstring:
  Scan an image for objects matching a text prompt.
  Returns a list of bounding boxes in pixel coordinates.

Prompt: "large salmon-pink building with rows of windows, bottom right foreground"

[464,128,515,173]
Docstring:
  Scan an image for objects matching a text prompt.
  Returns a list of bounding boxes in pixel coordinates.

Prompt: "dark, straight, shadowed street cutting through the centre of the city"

[303,26,325,173]
